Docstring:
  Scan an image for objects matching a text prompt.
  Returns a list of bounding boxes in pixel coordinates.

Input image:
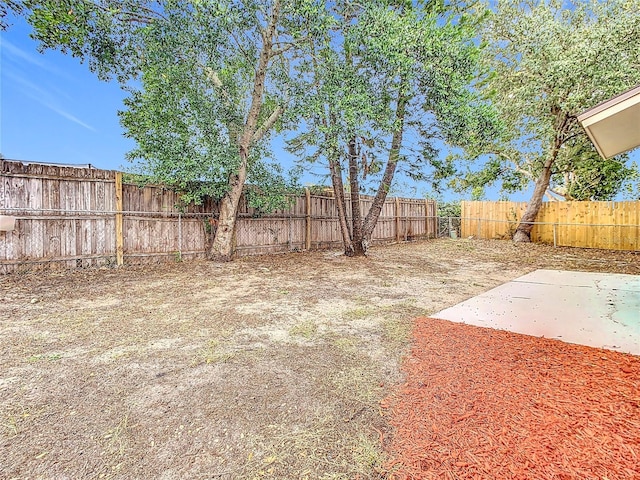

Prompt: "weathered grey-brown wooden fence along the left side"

[0,160,437,273]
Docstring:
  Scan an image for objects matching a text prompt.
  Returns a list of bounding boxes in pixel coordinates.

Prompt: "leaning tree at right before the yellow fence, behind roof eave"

[455,0,640,242]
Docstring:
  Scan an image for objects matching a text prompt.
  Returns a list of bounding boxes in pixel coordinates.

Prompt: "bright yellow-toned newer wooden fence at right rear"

[461,201,640,250]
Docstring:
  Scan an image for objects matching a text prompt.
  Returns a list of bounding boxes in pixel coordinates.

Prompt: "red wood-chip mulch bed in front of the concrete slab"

[383,318,640,480]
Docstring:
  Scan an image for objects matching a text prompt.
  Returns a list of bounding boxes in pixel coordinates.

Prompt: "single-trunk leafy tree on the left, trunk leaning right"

[19,0,323,261]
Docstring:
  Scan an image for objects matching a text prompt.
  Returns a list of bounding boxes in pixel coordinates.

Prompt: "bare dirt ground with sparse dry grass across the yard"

[0,240,640,479]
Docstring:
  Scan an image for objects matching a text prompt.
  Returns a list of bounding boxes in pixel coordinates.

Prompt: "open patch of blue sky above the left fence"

[0,16,139,169]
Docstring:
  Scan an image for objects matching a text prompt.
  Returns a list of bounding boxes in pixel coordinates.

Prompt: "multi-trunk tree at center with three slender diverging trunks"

[290,0,493,256]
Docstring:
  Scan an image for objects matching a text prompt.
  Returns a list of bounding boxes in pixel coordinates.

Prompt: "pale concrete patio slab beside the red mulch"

[433,270,640,355]
